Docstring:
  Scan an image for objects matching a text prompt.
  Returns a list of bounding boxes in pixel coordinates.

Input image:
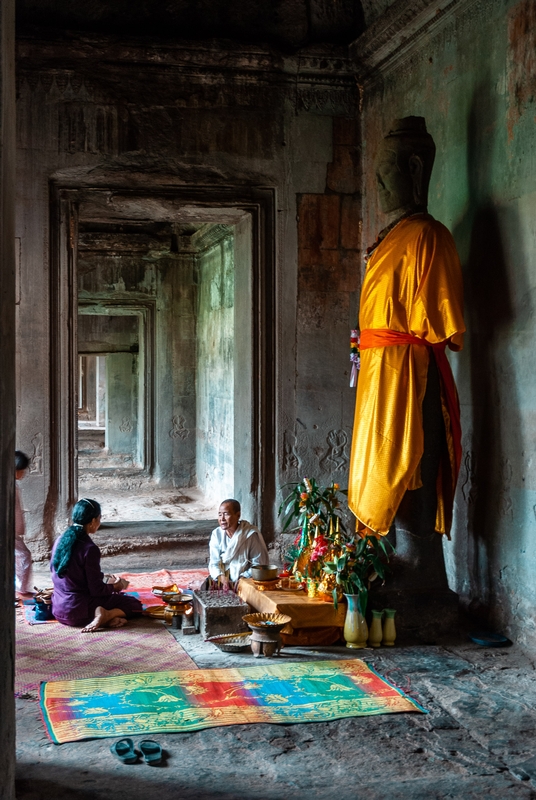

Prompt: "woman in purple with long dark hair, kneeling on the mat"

[50,499,142,633]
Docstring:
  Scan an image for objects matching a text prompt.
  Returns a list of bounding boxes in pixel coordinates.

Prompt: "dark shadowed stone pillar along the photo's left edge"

[0,0,15,800]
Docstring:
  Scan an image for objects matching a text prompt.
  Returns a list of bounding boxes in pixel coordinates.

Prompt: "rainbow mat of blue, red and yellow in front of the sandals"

[39,659,424,744]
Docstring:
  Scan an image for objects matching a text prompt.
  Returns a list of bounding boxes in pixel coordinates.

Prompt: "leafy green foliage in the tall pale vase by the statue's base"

[323,533,394,615]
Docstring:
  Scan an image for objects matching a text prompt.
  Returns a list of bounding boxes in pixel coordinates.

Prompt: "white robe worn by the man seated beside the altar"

[208,519,268,582]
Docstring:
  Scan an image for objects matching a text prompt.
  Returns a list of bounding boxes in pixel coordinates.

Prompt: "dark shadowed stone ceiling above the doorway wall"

[17,0,382,50]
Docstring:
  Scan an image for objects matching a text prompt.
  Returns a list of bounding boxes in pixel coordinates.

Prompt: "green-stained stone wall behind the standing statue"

[363,0,536,642]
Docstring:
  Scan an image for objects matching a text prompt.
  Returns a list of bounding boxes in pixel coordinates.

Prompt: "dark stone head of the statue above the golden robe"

[376,117,435,214]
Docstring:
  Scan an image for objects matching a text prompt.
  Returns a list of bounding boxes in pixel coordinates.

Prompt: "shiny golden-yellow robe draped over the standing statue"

[348,214,465,535]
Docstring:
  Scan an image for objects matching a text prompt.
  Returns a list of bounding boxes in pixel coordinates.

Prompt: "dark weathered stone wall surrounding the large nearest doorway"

[17,34,359,555]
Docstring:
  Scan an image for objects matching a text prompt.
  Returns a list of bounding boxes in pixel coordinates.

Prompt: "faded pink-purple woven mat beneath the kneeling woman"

[15,614,196,697]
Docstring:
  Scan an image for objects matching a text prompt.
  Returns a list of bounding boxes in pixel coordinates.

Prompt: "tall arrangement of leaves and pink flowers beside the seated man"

[279,478,347,595]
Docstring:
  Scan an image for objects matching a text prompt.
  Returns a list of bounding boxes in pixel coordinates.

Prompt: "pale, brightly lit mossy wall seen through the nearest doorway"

[192,225,235,500]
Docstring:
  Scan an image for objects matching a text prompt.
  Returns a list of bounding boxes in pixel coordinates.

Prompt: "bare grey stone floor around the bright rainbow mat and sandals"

[17,560,536,800]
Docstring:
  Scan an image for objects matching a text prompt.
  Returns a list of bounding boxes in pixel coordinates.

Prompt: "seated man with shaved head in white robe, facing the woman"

[208,500,268,584]
